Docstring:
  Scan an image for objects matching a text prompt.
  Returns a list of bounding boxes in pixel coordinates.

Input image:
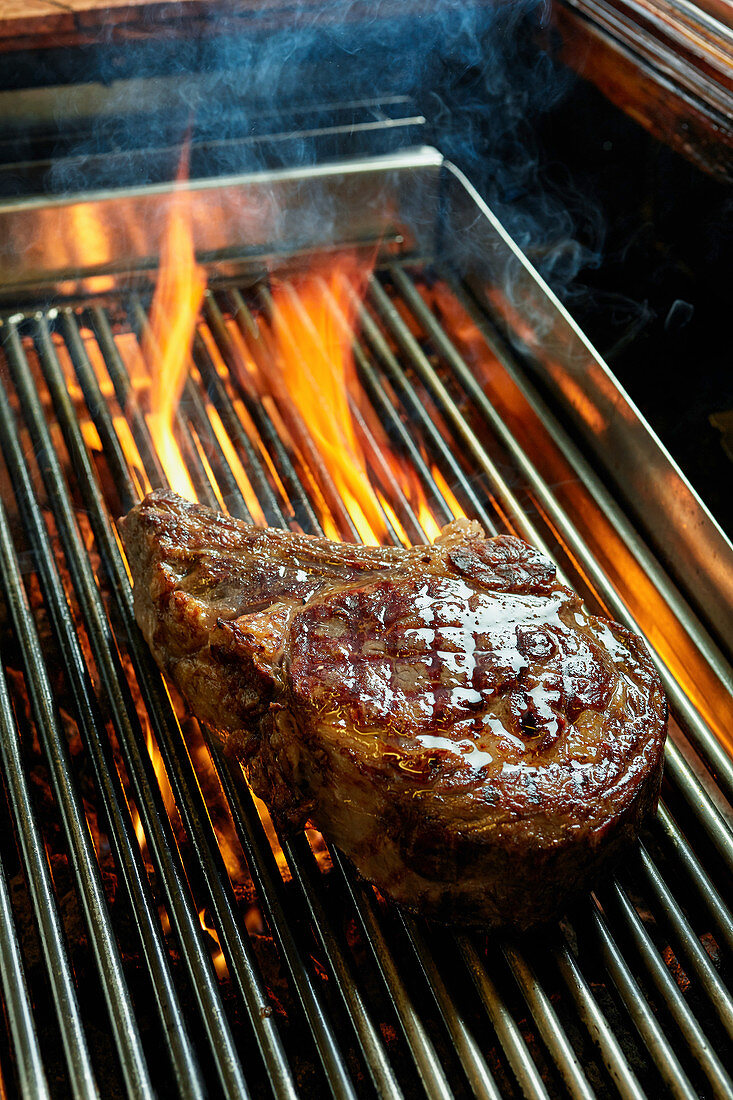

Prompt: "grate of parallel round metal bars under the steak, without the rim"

[0,251,733,1100]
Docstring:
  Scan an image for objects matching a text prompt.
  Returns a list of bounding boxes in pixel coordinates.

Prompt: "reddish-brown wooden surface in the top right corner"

[553,0,733,180]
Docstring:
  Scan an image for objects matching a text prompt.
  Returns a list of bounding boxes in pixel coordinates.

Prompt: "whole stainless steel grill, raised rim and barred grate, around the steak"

[0,151,733,1100]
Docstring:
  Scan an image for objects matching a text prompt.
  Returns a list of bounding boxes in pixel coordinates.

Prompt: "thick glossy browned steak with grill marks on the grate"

[121,492,667,928]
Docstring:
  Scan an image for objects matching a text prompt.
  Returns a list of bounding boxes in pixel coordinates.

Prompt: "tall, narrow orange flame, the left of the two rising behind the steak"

[142,150,206,499]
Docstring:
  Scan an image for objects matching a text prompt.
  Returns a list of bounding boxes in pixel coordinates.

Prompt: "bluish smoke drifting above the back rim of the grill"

[34,0,602,290]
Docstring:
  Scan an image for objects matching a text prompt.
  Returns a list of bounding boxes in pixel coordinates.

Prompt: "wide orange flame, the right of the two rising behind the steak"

[230,253,449,543]
